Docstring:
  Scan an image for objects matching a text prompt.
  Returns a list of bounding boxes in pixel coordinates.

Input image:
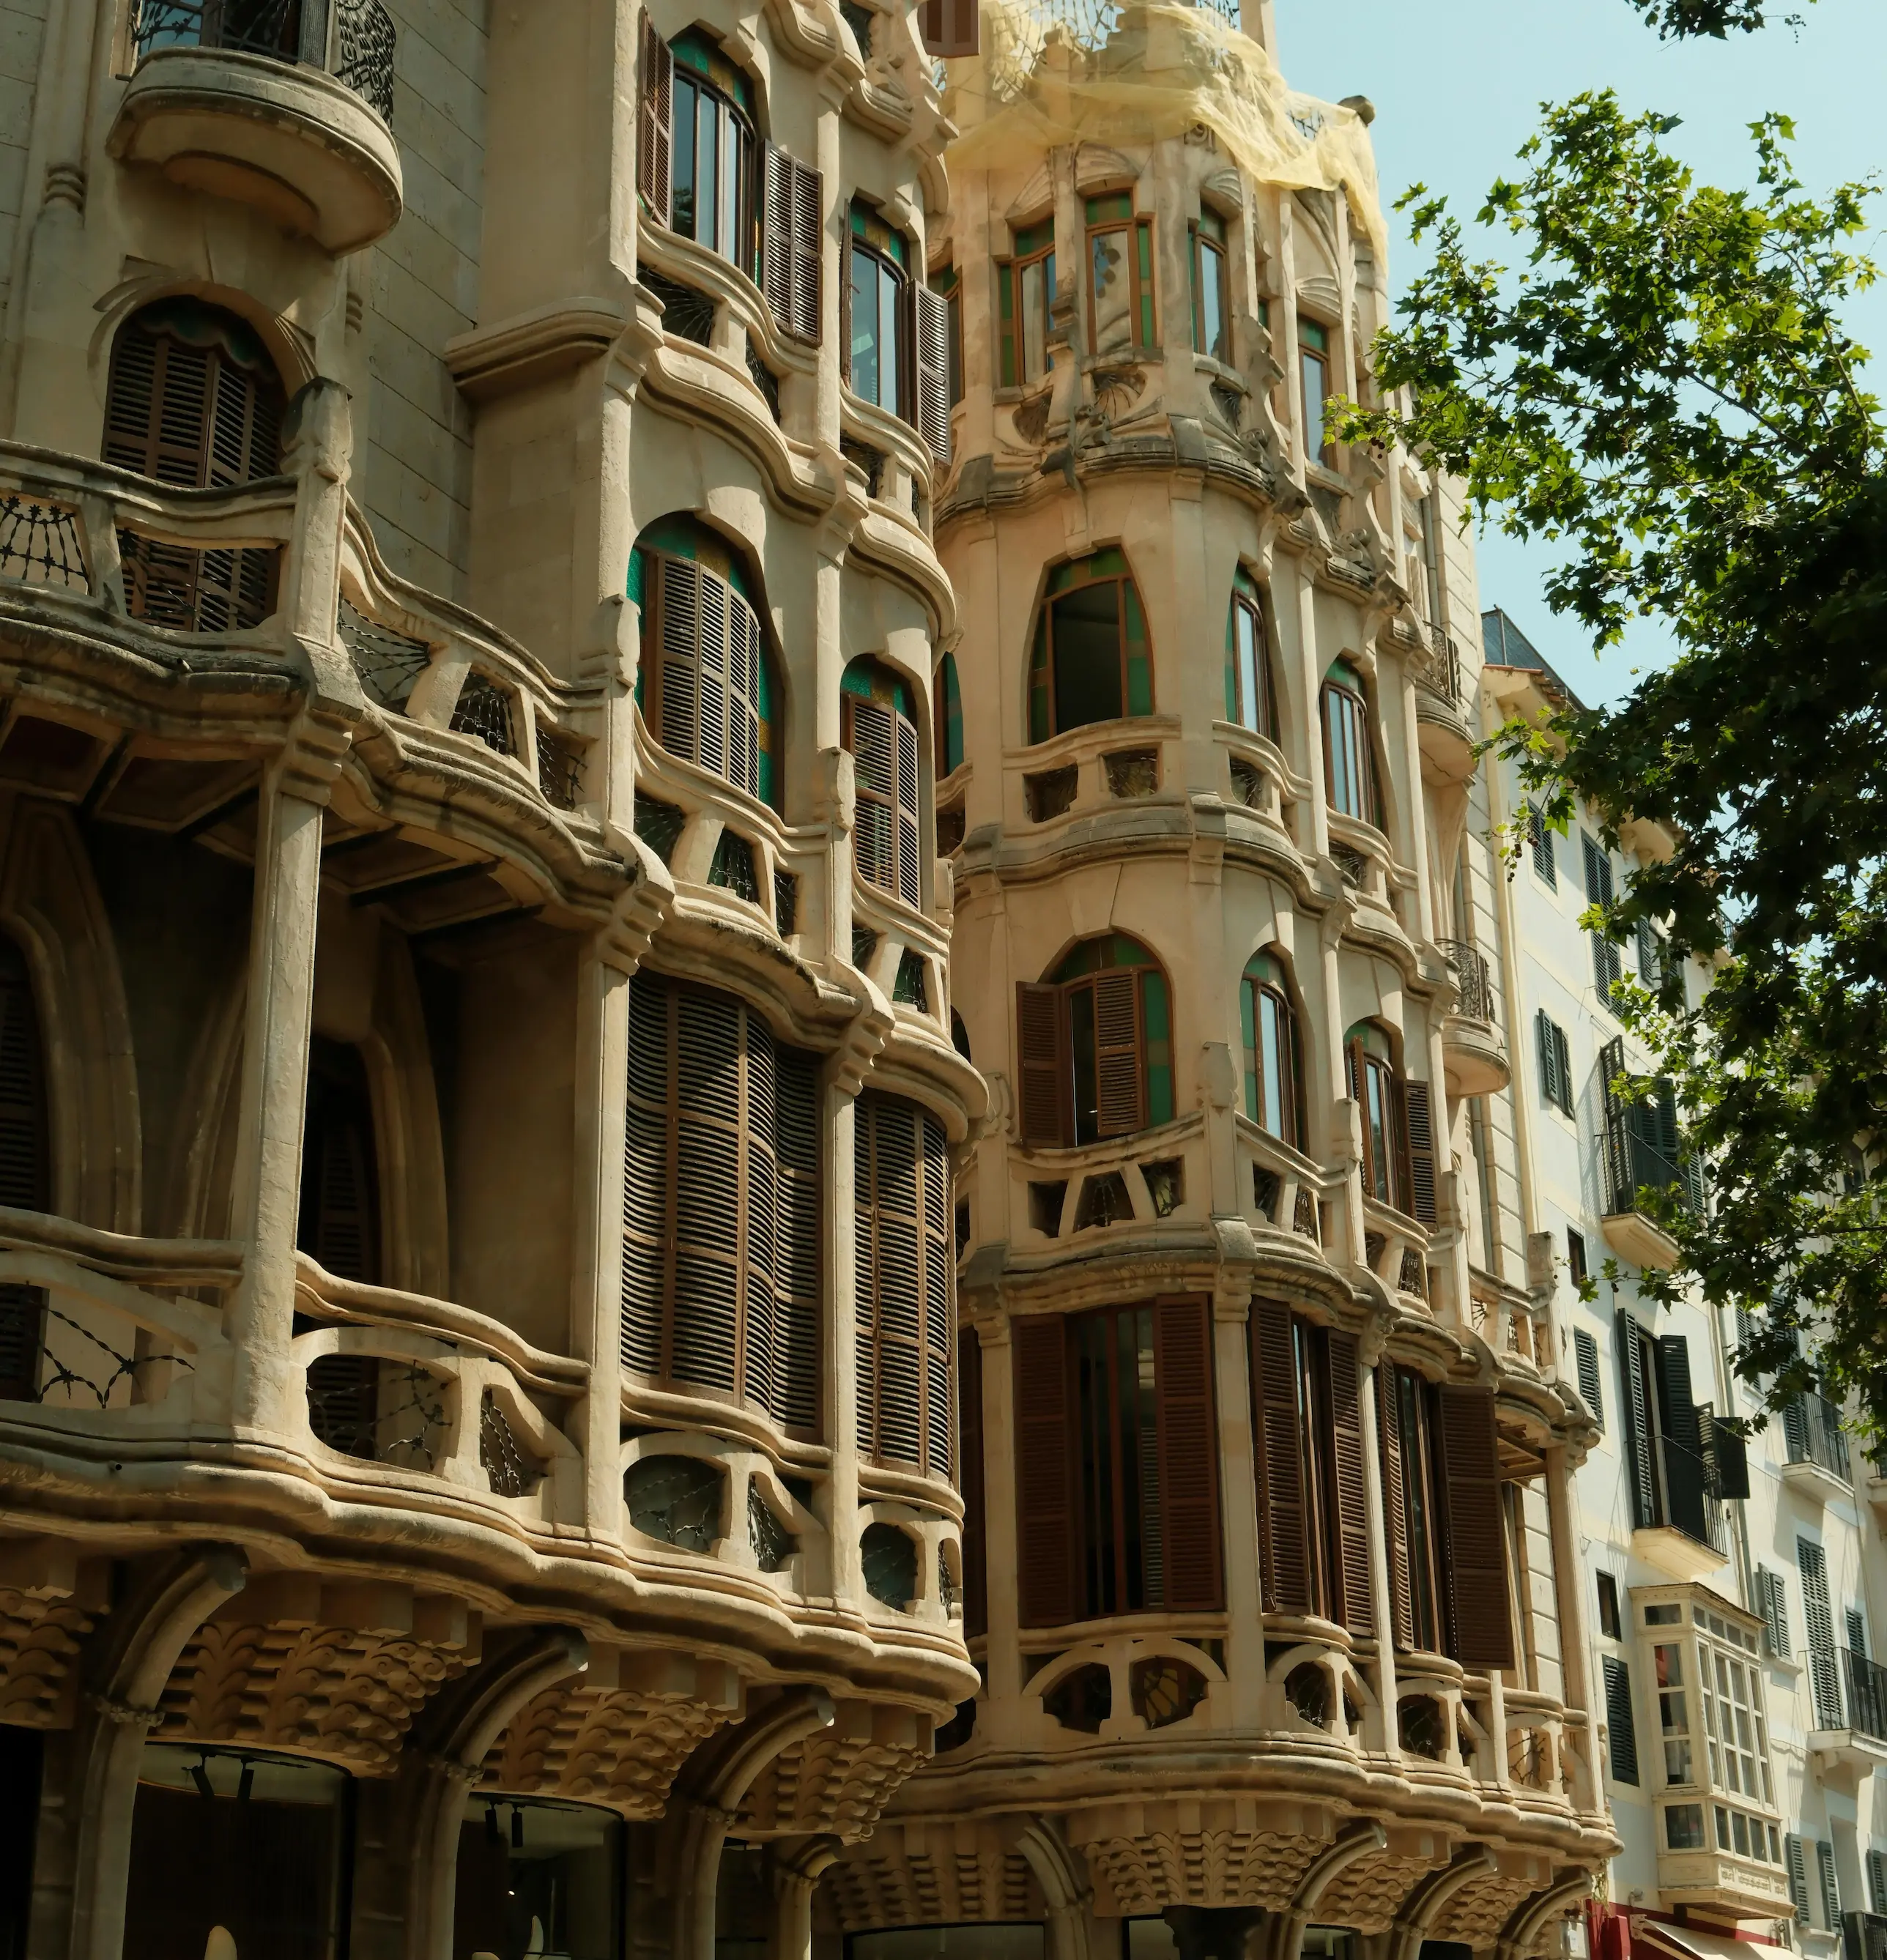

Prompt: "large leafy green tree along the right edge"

[1346,92,1887,1435]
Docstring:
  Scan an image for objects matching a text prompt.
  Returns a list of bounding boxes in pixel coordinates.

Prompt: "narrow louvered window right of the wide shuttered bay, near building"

[854,1092,956,1478]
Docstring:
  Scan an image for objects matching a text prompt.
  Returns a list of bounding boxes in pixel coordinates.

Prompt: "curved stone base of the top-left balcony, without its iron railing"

[108,45,404,257]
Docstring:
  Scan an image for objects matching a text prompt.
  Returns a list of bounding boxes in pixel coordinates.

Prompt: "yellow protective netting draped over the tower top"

[944,0,1385,251]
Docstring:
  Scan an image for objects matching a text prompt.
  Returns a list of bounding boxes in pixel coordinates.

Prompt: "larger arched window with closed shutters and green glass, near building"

[629,516,780,808]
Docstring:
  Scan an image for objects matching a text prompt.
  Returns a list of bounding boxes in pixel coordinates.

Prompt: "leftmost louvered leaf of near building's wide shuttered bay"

[621,966,676,1380]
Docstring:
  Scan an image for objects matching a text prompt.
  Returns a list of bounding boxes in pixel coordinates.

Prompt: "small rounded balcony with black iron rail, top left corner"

[108,0,404,257]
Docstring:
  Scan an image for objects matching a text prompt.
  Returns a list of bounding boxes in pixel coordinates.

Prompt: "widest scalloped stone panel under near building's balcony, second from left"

[153,1574,480,1775]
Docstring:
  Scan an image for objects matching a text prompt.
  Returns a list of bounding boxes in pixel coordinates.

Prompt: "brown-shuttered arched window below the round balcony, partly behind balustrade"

[104,296,284,633]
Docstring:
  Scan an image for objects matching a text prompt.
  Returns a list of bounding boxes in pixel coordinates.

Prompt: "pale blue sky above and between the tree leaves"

[1275,0,1887,704]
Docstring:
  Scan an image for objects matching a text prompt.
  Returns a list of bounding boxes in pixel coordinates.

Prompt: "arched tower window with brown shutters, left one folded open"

[1015,933,1174,1146]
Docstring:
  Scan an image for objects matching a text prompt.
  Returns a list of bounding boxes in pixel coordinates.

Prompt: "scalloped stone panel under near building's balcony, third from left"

[476,1650,741,1819]
